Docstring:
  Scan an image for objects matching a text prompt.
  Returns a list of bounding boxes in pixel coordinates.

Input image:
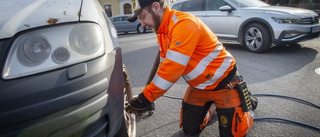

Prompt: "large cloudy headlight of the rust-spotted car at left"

[2,23,104,79]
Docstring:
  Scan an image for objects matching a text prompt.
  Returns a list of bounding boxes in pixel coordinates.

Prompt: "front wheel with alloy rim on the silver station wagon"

[241,23,271,53]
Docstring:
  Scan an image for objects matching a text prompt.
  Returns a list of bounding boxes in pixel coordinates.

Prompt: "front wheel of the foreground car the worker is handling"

[116,64,136,137]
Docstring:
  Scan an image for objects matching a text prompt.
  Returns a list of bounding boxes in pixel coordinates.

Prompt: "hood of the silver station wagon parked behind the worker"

[244,6,318,18]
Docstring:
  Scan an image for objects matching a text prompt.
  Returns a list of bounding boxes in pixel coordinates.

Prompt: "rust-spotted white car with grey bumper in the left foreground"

[0,0,135,137]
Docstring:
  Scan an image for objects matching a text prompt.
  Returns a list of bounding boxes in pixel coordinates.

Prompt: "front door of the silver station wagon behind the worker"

[198,0,238,41]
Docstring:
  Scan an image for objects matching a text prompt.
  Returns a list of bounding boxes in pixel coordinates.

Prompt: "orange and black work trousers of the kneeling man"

[181,81,253,137]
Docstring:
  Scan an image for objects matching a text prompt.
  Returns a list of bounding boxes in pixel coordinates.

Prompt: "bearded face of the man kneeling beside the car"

[138,6,161,33]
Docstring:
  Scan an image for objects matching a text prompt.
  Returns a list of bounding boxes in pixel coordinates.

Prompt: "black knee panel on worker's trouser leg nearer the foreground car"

[180,101,212,135]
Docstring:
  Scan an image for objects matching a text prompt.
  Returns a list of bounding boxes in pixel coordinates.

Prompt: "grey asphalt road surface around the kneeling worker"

[119,32,320,137]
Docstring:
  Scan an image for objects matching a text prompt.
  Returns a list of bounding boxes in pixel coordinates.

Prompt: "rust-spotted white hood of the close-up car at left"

[0,0,82,39]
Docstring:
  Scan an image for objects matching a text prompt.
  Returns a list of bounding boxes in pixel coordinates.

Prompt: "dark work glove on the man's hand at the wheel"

[126,93,154,115]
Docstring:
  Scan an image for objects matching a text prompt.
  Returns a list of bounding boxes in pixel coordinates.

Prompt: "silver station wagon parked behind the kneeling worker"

[170,0,320,52]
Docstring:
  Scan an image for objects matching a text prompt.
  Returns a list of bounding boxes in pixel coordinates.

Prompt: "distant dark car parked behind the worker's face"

[110,15,150,33]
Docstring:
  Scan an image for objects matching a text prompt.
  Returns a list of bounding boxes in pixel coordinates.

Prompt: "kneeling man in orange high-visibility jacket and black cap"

[127,0,255,137]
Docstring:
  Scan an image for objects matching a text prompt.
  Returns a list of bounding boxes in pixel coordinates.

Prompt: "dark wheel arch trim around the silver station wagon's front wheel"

[238,18,275,46]
